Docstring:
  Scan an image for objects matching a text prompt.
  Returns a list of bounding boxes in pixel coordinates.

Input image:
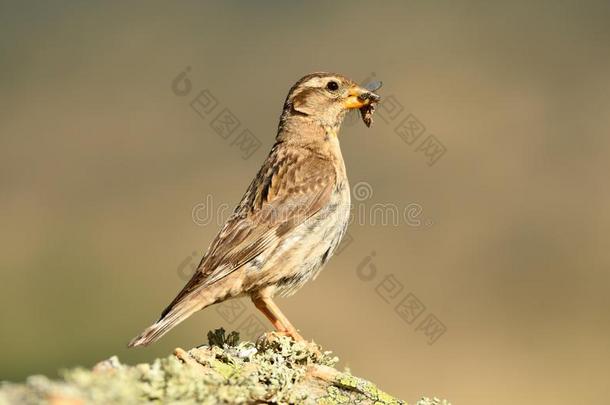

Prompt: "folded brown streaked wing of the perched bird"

[164,148,337,313]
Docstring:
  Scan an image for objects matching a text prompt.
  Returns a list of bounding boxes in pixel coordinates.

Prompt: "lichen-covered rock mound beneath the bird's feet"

[0,330,444,405]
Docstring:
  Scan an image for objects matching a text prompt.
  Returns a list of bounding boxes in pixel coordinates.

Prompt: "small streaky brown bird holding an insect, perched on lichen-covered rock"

[129,73,381,347]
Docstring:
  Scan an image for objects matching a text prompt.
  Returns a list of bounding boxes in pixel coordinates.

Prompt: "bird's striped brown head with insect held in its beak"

[282,72,381,129]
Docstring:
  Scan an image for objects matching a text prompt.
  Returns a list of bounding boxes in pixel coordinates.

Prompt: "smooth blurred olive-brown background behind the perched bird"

[0,1,610,404]
